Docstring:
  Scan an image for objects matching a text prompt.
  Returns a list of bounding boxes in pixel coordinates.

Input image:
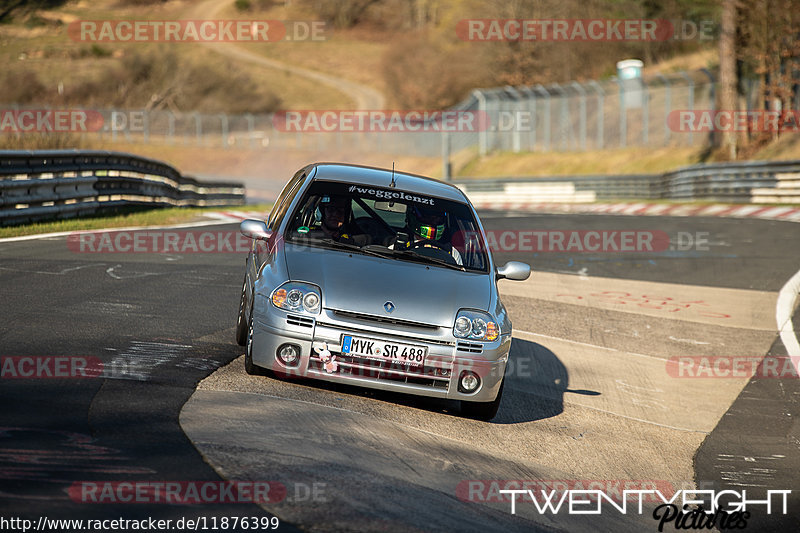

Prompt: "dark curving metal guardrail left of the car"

[0,150,245,225]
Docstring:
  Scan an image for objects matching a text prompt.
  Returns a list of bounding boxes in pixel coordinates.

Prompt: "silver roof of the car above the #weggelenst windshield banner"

[311,163,469,203]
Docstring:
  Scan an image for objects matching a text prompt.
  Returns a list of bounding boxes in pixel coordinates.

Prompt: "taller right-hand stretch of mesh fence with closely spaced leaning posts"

[465,70,720,155]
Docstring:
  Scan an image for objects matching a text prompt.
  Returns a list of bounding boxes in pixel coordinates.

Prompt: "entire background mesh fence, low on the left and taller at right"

[4,69,758,161]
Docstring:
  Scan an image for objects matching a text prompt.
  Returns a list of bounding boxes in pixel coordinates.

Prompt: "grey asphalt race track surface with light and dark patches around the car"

[0,213,800,531]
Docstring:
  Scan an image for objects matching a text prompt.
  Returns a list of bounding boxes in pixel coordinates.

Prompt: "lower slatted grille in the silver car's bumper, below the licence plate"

[308,353,452,391]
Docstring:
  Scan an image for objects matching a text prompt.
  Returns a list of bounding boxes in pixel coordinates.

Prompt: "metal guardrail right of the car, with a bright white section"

[455,161,800,204]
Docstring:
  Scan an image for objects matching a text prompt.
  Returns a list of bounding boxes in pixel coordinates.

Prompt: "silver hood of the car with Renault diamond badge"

[285,244,492,327]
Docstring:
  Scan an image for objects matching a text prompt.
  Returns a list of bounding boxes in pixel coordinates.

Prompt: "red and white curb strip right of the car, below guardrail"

[473,202,800,222]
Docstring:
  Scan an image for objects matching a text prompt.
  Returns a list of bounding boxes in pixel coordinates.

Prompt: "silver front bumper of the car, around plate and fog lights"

[252,297,511,402]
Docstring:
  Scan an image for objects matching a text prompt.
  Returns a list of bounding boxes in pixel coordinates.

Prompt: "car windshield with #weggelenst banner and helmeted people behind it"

[285,181,488,272]
